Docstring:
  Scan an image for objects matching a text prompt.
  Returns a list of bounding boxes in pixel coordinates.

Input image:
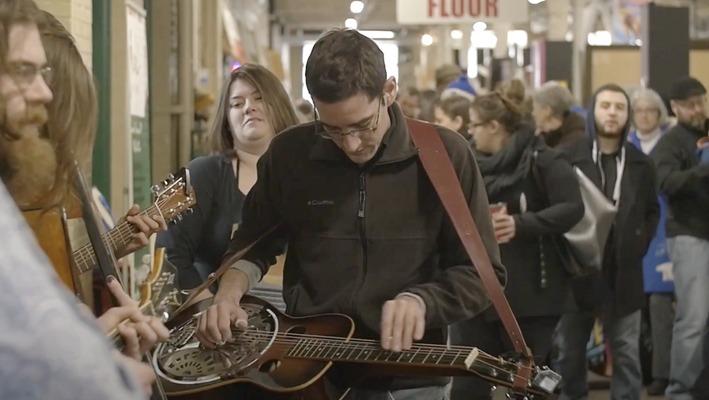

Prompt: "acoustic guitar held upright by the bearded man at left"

[23,168,197,300]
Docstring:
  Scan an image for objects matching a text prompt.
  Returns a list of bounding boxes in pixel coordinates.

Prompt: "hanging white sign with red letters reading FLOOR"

[396,0,529,25]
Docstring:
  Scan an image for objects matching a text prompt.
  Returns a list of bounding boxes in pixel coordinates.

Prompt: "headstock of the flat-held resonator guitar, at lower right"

[466,349,561,399]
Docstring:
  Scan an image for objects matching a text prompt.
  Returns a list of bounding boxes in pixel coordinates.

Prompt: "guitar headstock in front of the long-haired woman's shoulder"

[151,168,197,223]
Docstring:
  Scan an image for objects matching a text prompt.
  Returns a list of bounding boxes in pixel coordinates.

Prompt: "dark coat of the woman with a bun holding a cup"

[478,126,583,318]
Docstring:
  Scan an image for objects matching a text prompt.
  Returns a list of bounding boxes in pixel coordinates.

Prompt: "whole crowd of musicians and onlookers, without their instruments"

[0,0,709,400]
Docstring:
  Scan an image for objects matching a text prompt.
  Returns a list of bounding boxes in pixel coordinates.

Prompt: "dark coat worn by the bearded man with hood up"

[569,139,660,316]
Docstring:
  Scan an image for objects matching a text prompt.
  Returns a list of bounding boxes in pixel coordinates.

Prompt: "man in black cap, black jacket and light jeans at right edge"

[650,77,709,400]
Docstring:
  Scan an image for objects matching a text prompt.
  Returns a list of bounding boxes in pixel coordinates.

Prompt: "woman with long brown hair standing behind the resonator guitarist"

[158,64,298,296]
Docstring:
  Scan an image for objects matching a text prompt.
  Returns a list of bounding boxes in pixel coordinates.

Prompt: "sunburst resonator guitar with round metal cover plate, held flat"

[152,296,561,400]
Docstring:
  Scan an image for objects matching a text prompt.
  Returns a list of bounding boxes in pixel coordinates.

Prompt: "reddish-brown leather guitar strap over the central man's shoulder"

[406,119,534,388]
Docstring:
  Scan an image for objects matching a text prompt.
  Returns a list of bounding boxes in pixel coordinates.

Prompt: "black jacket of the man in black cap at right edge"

[650,124,709,240]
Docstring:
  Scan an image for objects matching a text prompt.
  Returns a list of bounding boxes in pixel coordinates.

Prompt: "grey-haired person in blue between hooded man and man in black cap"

[628,88,675,396]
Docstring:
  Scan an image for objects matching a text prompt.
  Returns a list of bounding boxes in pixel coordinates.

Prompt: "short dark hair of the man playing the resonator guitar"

[305,29,386,103]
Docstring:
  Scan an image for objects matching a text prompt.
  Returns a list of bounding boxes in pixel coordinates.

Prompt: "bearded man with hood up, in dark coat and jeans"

[558,84,659,399]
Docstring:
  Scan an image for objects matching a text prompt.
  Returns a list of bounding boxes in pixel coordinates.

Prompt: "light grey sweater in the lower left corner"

[0,182,144,400]
